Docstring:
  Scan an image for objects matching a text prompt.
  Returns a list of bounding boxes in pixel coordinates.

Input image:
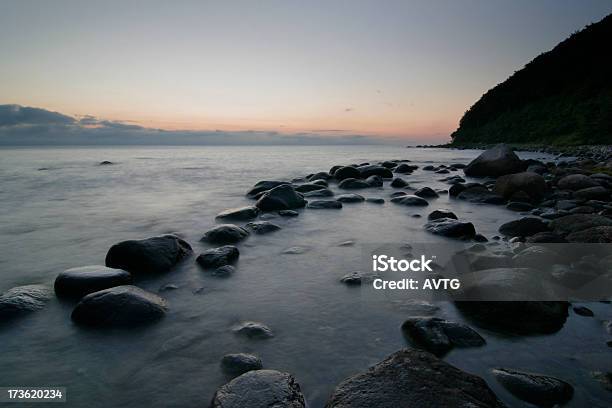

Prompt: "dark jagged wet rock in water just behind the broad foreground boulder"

[402,317,485,356]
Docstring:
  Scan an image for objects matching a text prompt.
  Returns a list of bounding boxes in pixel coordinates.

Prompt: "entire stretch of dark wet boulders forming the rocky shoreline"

[0,145,612,408]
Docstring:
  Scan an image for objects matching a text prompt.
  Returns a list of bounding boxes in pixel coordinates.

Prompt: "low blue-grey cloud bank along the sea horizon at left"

[0,105,392,146]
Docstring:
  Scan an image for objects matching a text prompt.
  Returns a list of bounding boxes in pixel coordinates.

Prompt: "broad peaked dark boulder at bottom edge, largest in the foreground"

[326,349,504,408]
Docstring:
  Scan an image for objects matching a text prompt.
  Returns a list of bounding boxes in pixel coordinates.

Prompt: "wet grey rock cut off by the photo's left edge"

[0,285,51,323]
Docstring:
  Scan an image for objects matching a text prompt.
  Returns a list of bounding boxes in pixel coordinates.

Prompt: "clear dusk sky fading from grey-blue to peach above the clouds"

[0,0,612,143]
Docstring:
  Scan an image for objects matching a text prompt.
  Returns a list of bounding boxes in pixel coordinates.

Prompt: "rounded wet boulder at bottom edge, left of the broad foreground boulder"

[210,370,306,408]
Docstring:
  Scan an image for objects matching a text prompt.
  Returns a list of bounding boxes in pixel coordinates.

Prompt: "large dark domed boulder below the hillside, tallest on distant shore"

[463,144,525,177]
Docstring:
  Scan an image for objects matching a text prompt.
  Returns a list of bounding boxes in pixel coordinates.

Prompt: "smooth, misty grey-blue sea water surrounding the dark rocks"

[0,146,612,407]
